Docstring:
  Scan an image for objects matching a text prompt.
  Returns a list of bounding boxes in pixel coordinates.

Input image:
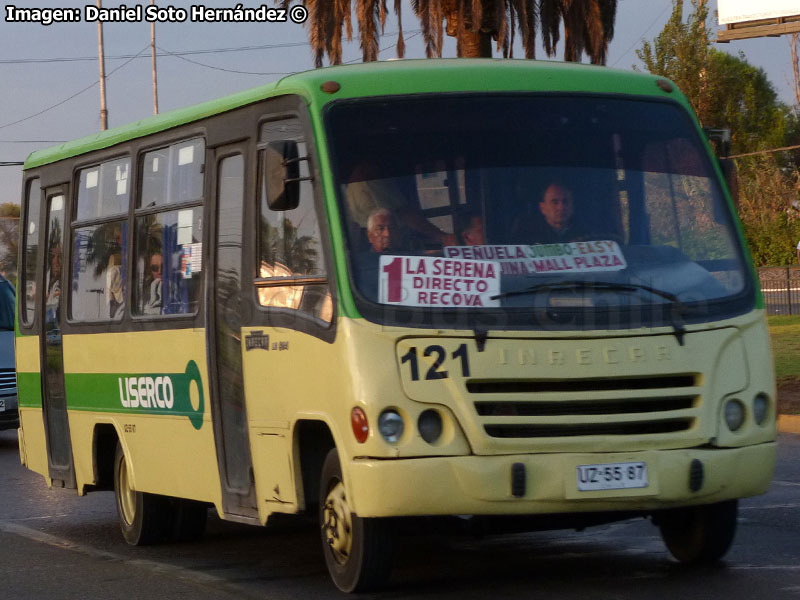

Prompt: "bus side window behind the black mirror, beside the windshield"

[256,119,333,323]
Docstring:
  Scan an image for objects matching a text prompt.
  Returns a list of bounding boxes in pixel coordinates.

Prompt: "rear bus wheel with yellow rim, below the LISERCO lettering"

[114,443,175,546]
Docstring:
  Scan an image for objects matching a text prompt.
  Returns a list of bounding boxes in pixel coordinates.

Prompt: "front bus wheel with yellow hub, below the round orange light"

[319,448,394,592]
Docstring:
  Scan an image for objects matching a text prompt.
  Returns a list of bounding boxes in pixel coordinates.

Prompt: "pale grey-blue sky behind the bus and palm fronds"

[0,0,795,203]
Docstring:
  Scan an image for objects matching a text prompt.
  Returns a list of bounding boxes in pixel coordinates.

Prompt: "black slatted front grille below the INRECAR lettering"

[467,373,702,439]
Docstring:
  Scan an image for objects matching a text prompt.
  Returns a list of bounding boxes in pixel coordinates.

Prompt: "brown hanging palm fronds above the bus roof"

[282,0,617,67]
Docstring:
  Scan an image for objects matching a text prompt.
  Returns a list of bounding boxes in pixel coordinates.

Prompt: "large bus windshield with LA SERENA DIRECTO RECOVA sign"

[326,94,753,326]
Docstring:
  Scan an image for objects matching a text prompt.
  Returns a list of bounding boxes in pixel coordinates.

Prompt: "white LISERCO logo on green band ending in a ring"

[117,360,205,429]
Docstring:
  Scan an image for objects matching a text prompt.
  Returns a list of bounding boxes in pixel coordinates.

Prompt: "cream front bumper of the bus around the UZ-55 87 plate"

[346,442,776,517]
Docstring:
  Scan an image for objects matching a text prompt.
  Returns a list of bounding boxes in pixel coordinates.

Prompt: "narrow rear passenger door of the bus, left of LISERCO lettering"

[39,188,76,488]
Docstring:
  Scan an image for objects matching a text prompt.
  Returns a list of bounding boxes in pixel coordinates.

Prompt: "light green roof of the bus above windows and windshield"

[24,58,685,169]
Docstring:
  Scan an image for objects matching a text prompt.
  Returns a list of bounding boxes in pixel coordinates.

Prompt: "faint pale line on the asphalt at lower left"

[0,520,263,598]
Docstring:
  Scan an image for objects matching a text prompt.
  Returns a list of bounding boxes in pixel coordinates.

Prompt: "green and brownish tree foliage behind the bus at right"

[636,0,800,265]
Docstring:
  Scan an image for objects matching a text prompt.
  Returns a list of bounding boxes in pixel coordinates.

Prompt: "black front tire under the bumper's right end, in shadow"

[657,500,739,565]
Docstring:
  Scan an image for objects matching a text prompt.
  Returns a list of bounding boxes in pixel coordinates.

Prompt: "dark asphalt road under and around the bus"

[0,431,800,600]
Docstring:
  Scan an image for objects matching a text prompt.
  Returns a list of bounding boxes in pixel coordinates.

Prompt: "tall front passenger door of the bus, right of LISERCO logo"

[206,145,258,520]
